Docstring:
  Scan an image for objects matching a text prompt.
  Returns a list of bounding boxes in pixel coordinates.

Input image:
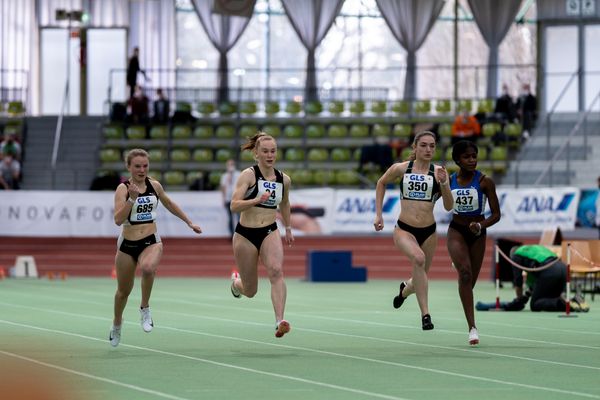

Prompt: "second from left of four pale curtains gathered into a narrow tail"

[281,0,344,101]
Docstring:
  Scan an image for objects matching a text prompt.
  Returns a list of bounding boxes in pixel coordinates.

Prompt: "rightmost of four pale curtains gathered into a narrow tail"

[469,0,521,99]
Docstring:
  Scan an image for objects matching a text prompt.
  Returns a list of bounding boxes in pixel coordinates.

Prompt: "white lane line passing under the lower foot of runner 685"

[0,319,408,400]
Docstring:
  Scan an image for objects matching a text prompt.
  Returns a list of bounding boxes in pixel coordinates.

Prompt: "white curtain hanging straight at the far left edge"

[0,0,39,115]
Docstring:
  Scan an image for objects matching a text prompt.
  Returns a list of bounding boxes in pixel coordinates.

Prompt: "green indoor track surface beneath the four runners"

[0,277,600,400]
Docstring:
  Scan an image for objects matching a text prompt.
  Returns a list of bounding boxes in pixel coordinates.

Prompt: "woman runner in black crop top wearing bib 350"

[373,131,453,330]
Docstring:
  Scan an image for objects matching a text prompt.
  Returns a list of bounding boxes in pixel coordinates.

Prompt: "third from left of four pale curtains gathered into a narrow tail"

[377,0,444,100]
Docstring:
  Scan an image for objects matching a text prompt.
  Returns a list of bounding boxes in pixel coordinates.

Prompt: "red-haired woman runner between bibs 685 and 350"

[231,132,294,338]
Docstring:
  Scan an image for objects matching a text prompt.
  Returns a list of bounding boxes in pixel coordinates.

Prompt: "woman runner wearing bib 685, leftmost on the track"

[108,149,202,347]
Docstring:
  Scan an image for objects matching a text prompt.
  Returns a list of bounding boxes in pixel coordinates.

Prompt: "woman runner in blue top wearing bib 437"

[447,140,500,345]
